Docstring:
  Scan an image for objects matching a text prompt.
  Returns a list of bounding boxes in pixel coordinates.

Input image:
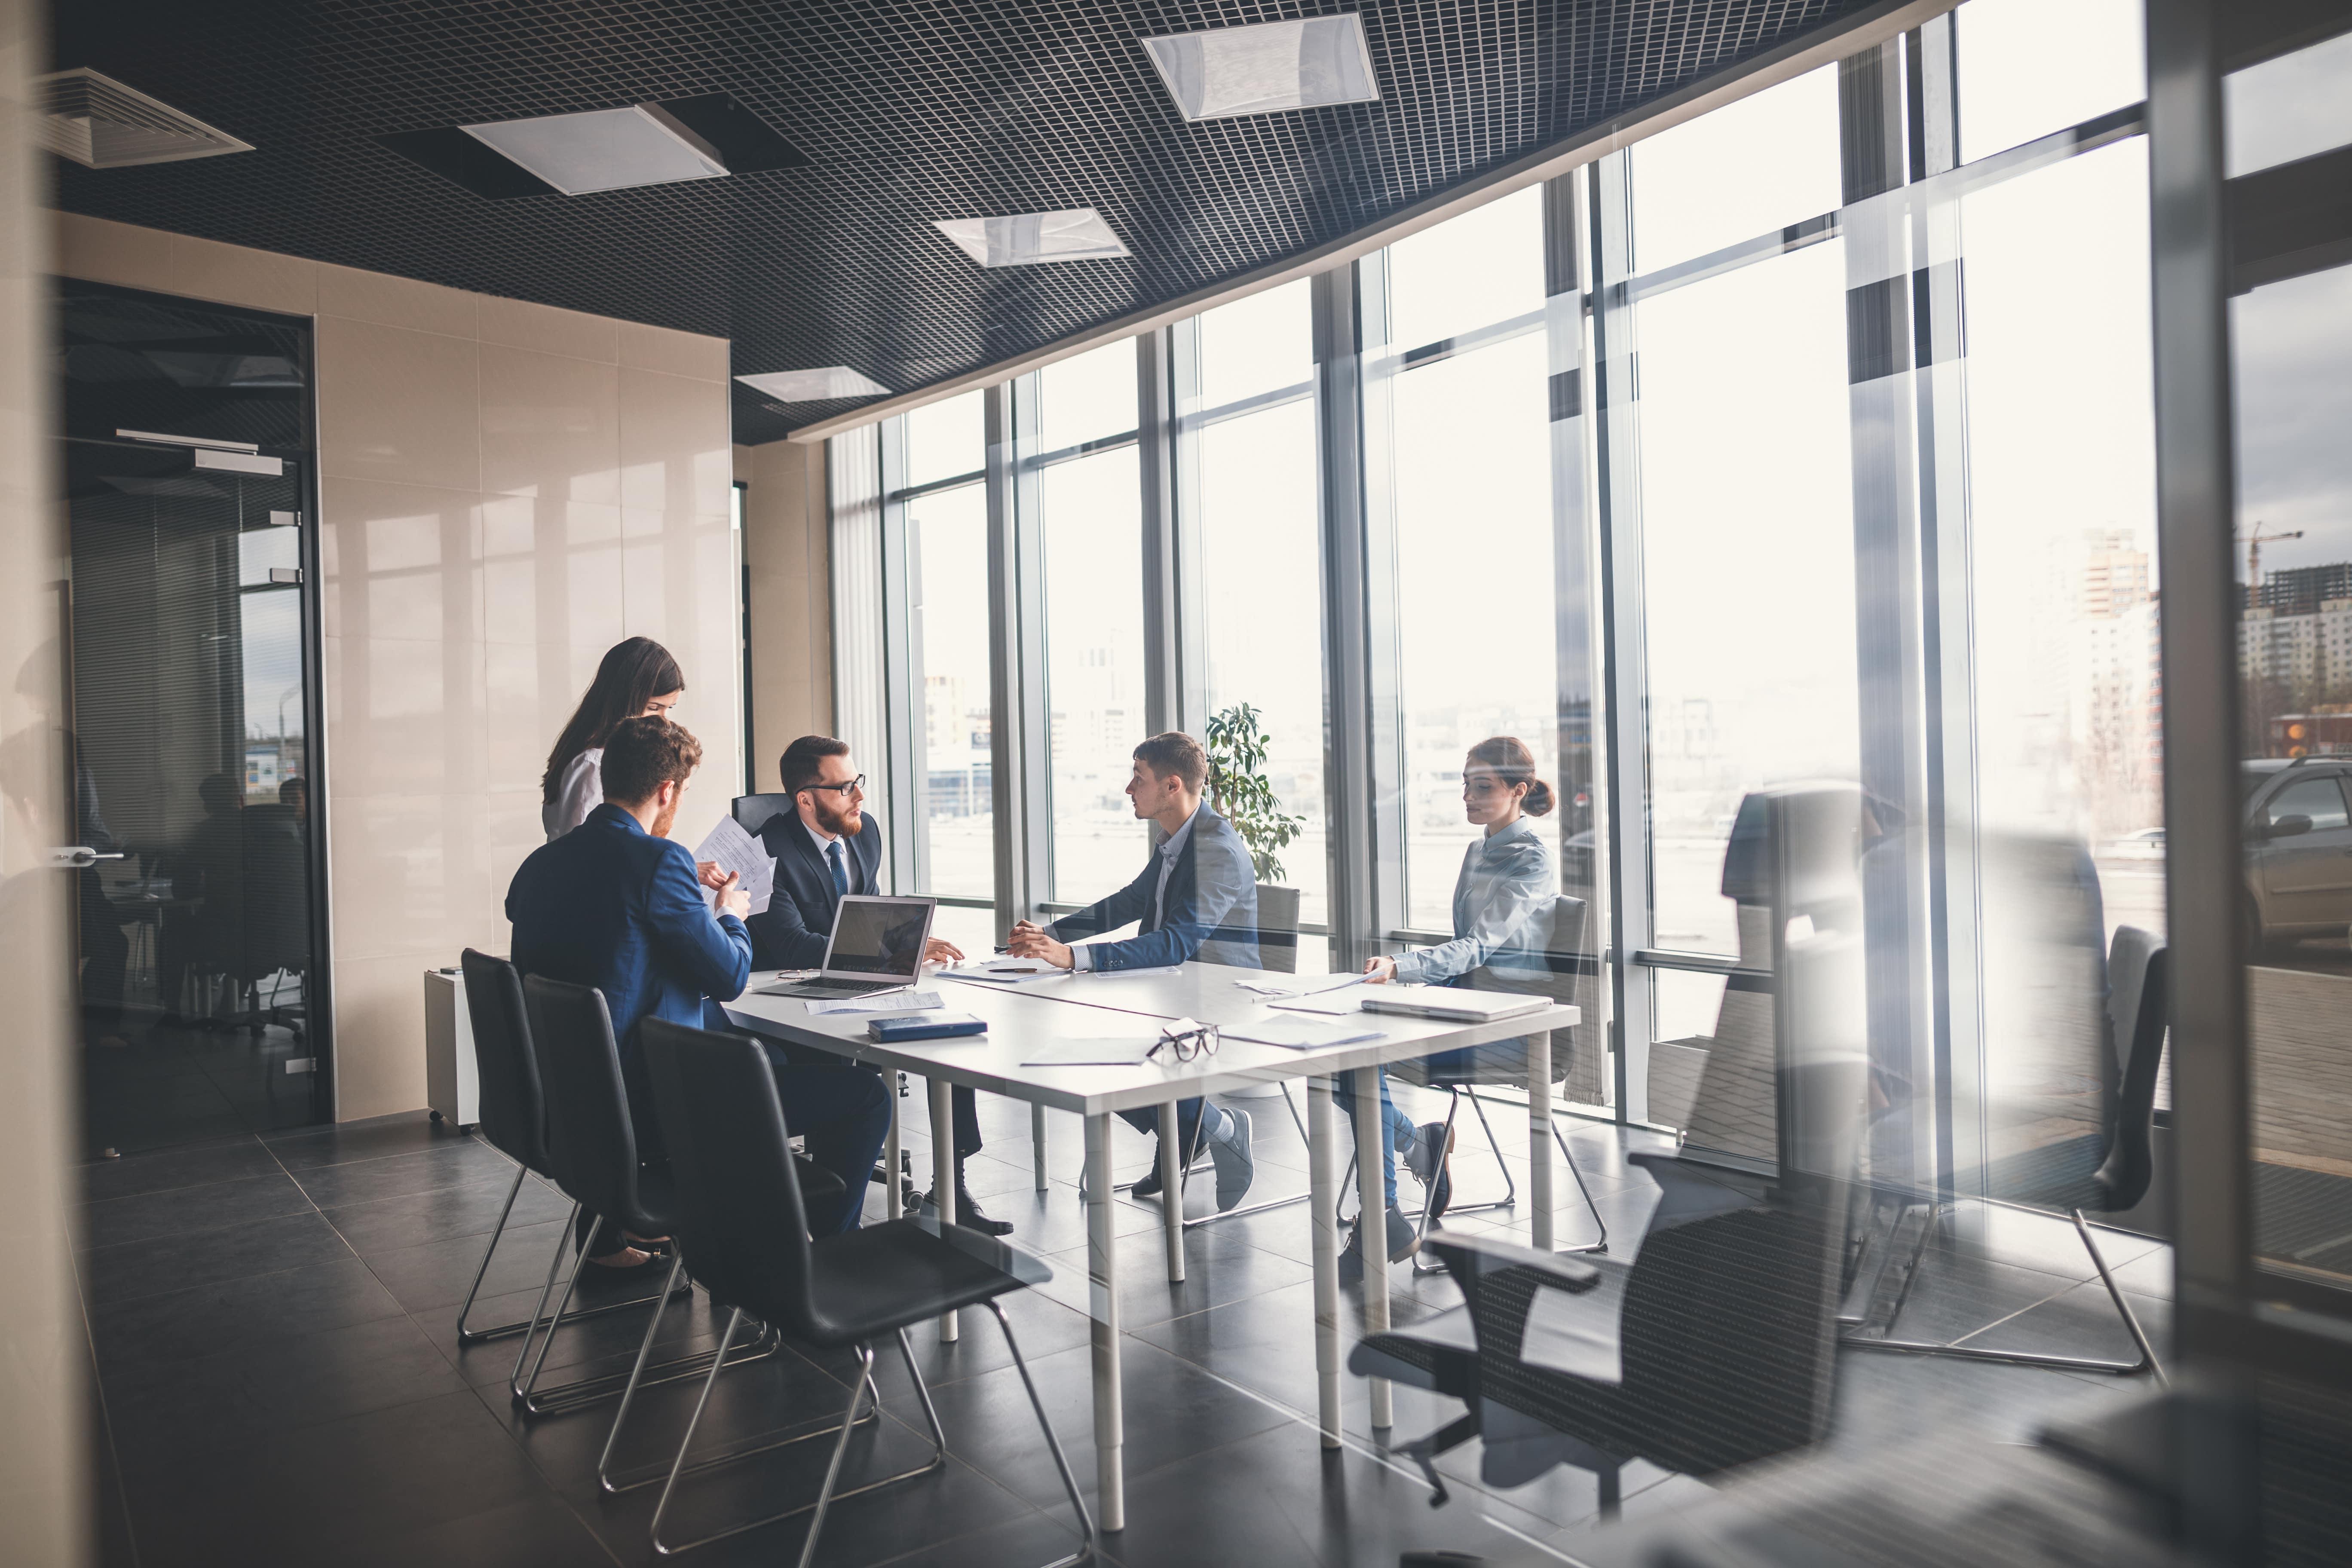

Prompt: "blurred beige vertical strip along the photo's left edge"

[0,0,96,1568]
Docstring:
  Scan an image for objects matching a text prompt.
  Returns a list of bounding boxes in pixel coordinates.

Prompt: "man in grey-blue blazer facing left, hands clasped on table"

[1009,729,1259,1208]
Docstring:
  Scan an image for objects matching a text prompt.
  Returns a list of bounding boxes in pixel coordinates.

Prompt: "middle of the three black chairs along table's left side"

[510,976,795,1420]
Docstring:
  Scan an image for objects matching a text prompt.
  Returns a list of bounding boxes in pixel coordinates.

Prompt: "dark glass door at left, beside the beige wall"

[59,285,325,1157]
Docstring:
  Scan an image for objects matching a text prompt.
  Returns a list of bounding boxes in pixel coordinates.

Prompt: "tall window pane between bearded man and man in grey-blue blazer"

[1037,447,1150,903]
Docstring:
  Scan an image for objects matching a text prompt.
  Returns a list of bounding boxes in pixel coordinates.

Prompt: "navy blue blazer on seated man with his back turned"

[505,802,750,1086]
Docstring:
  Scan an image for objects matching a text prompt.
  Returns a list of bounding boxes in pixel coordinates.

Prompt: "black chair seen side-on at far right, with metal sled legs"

[1847,926,2168,1382]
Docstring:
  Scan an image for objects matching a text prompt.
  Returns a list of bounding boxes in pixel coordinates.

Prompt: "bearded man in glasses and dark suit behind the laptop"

[748,736,1011,1237]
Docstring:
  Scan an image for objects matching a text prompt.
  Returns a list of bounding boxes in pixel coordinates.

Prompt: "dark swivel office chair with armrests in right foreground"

[1348,1058,1863,1514]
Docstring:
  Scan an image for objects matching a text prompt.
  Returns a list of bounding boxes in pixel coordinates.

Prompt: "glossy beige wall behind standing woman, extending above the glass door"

[57,215,734,1121]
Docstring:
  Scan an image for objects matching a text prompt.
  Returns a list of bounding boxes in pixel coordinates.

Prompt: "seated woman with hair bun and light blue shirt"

[1331,736,1559,1281]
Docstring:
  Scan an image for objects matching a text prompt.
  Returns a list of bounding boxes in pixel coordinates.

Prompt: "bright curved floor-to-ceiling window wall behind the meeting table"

[846,0,2201,1260]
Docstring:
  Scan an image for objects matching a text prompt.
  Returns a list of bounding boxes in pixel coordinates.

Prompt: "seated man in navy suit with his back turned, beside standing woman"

[505,717,889,1267]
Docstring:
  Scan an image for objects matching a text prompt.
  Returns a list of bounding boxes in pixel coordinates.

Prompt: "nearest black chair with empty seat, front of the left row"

[642,1023,1093,1568]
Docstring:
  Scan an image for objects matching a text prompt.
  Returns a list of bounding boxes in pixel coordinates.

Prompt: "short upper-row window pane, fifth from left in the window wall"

[1632,66,1839,273]
